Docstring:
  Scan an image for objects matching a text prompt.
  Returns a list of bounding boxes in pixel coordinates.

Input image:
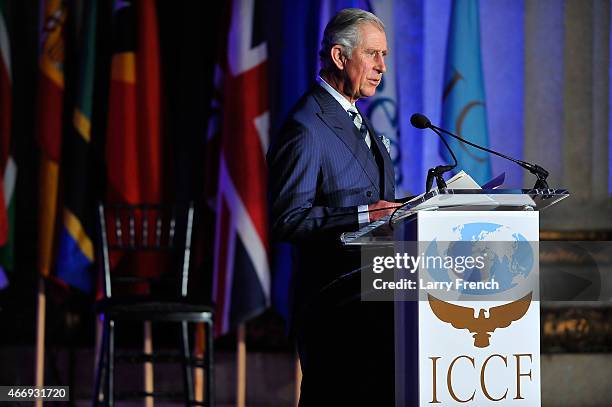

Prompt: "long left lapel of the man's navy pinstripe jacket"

[313,85,380,191]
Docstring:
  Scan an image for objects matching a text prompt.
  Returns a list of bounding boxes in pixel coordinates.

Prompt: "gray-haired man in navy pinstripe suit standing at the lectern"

[267,9,397,406]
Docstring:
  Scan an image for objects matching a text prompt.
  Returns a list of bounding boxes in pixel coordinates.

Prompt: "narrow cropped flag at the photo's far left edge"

[0,0,17,289]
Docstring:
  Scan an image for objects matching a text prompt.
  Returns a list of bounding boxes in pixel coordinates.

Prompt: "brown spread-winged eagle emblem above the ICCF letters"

[427,293,532,348]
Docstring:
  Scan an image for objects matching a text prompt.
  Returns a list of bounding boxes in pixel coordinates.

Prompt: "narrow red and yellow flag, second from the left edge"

[36,0,67,277]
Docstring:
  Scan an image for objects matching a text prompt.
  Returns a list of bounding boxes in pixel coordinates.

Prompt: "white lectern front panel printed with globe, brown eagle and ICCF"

[417,211,540,407]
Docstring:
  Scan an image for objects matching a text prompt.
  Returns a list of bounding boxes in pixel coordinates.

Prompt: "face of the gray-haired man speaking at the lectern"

[344,24,388,102]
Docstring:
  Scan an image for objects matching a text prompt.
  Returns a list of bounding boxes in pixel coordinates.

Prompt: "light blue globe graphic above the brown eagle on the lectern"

[423,222,535,295]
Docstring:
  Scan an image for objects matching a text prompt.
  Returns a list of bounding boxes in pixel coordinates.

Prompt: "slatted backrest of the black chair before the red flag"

[97,202,194,298]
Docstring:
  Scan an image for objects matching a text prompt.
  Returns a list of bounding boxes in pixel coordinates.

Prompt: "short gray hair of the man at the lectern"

[319,8,385,71]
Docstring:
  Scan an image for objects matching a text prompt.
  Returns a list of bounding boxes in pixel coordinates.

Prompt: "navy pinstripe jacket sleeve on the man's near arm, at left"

[267,122,358,242]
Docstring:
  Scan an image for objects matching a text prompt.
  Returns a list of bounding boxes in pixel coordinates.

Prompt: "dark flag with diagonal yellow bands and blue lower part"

[56,2,97,292]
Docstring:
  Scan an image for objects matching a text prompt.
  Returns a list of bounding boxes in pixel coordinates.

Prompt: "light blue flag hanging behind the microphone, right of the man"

[439,0,491,184]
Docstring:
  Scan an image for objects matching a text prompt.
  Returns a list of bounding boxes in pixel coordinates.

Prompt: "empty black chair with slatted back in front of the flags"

[94,203,214,406]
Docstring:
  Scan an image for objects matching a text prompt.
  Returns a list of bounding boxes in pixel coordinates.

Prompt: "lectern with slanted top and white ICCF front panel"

[341,189,569,407]
